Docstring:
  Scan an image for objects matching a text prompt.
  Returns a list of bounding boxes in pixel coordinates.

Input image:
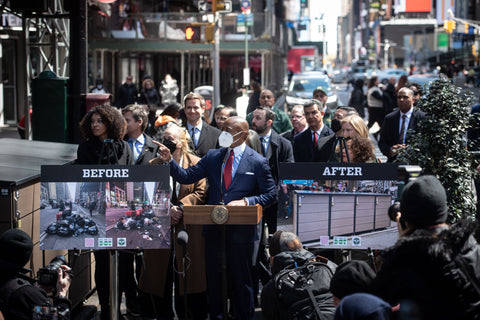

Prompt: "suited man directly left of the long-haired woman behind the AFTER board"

[293,99,334,162]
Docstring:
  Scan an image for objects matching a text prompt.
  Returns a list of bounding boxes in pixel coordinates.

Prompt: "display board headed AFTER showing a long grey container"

[279,163,399,249]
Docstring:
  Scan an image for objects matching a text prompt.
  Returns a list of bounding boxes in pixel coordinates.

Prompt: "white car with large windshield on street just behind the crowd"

[286,71,338,110]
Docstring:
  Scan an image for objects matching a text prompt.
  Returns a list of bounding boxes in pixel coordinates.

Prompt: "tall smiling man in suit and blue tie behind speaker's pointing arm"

[183,93,221,158]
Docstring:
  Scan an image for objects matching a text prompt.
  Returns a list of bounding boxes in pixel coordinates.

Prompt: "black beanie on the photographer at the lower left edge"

[0,229,33,267]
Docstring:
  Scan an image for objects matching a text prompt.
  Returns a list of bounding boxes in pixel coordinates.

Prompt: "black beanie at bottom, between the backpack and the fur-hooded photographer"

[330,260,375,299]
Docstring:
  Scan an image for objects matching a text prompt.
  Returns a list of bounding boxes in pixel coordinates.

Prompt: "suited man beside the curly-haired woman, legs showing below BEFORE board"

[118,104,158,316]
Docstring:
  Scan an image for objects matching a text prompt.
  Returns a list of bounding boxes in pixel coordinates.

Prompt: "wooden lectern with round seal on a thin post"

[183,204,262,319]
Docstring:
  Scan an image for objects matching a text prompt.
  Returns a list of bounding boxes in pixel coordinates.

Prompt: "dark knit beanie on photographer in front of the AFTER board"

[400,175,448,227]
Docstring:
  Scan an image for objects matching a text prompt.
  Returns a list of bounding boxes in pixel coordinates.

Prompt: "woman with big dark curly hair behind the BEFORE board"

[77,105,133,164]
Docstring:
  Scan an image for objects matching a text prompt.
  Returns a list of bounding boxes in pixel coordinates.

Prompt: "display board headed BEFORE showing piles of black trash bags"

[40,165,171,250]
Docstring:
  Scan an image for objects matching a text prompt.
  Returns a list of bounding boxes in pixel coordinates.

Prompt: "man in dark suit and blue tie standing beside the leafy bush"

[378,88,425,162]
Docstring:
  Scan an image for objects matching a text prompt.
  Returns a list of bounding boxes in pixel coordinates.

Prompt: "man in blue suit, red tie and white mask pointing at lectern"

[158,117,276,320]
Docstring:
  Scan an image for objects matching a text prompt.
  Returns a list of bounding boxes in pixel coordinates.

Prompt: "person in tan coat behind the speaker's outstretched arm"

[139,123,208,319]
